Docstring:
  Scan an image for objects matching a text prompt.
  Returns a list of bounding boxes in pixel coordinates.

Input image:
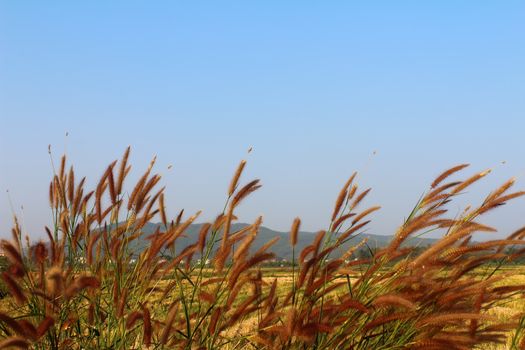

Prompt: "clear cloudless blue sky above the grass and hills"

[0,0,525,239]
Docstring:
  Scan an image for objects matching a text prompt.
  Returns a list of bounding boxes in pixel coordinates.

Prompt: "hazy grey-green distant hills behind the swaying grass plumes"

[131,223,436,260]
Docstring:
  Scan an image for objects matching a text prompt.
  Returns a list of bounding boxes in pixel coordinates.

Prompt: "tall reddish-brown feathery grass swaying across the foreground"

[0,148,525,349]
